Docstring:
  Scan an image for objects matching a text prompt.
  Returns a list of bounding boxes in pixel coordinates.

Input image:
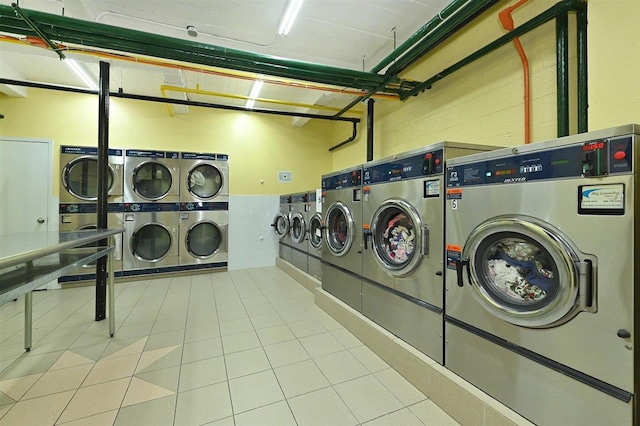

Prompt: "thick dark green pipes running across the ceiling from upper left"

[0,5,396,90]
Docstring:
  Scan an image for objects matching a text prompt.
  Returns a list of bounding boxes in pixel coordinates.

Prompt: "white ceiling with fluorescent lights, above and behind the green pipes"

[0,0,450,120]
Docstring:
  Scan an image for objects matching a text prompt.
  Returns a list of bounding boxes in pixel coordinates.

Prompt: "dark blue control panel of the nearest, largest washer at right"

[446,136,633,187]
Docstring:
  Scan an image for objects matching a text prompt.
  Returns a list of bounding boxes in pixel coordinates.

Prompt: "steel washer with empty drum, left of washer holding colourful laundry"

[322,166,362,311]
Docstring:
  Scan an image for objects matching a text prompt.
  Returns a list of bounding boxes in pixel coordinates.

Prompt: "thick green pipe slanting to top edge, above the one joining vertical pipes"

[386,0,498,75]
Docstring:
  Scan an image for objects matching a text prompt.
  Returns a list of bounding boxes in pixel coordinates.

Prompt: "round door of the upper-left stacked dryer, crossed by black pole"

[62,157,115,201]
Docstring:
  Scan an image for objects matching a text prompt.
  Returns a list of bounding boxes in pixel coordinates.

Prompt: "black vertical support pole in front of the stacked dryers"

[96,61,109,321]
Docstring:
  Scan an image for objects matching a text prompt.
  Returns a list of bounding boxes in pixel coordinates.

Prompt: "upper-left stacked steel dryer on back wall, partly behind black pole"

[60,145,124,203]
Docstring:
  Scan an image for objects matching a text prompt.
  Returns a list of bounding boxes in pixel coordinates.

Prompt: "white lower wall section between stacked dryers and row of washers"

[228,195,280,270]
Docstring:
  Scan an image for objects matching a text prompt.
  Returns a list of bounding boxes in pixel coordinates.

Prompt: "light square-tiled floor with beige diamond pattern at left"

[0,267,457,426]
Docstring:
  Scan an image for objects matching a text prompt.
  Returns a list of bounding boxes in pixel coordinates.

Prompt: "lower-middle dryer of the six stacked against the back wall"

[122,203,180,276]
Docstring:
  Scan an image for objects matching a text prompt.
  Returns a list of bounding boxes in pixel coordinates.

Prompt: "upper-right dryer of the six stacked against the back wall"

[180,152,229,203]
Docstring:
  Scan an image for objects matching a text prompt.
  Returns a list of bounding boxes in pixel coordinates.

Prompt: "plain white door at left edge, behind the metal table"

[0,138,54,235]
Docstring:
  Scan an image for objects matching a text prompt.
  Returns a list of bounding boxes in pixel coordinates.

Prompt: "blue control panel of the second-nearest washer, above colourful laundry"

[363,149,443,185]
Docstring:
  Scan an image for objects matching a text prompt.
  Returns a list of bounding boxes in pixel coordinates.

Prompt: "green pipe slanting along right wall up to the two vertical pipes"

[400,0,585,100]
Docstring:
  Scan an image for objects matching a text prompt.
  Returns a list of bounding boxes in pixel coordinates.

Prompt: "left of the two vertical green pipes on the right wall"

[556,12,569,138]
